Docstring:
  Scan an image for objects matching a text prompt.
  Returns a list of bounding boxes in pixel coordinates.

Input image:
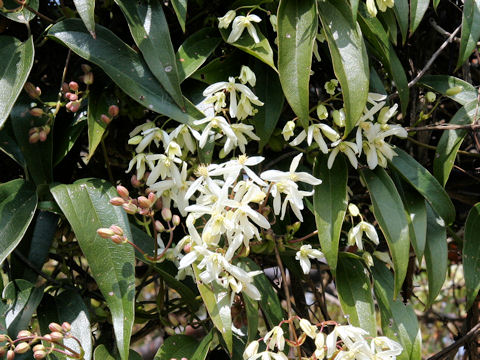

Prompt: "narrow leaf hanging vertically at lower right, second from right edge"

[425,204,448,309]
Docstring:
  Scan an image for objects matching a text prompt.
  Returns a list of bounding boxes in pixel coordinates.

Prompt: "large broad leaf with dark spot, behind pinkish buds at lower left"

[51,179,135,359]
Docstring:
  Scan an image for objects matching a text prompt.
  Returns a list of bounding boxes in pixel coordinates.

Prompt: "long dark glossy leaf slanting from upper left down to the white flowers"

[48,19,203,123]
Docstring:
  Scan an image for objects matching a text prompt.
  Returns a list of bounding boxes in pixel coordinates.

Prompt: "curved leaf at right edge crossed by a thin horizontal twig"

[433,100,479,187]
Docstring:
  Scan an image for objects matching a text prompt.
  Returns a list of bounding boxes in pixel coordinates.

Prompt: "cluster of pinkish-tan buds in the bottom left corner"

[0,322,84,360]
